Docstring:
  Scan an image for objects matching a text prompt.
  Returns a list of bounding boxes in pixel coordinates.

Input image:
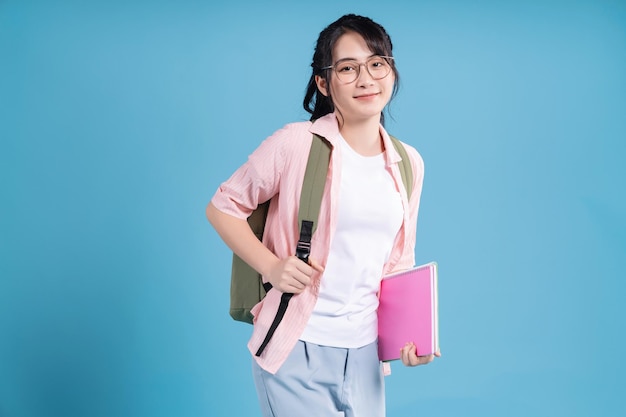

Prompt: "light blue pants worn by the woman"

[252,341,385,417]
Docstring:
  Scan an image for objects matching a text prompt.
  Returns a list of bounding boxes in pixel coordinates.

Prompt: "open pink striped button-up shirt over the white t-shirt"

[211,113,424,373]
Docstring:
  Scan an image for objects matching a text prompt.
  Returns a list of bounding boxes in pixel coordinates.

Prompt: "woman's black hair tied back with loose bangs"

[302,14,400,123]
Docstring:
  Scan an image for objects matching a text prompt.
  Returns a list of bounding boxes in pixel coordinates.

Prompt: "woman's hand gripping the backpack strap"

[267,256,324,294]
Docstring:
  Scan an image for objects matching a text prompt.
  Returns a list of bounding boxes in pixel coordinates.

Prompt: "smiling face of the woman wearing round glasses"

[316,32,395,123]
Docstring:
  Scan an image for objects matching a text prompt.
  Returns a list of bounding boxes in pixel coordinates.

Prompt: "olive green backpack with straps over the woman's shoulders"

[230,135,413,356]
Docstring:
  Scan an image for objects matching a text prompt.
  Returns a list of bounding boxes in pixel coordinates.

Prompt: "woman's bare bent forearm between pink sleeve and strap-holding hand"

[206,203,279,276]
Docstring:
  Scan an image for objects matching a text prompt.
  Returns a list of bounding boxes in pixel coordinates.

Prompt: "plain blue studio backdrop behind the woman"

[0,0,626,417]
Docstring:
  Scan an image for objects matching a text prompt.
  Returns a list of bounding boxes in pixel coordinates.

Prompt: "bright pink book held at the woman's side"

[378,262,439,361]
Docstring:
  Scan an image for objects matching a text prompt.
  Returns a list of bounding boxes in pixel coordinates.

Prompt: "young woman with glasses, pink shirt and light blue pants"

[207,15,433,417]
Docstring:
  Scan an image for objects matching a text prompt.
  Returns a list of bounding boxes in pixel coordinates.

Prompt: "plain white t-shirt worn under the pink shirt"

[300,139,403,348]
